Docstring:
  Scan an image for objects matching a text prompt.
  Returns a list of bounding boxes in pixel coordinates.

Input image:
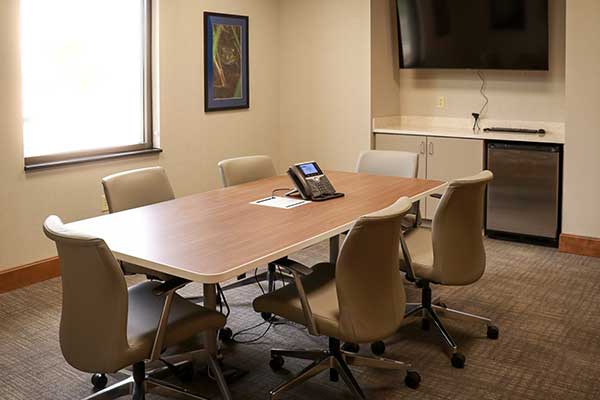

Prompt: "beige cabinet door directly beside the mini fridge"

[425,136,484,219]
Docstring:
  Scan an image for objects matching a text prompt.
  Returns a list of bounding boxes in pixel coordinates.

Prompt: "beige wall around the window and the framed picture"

[0,0,280,270]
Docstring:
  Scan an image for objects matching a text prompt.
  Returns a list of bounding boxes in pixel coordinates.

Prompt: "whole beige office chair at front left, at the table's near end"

[44,216,231,400]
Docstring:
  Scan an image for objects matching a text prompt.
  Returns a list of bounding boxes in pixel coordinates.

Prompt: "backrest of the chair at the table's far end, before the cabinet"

[356,150,419,178]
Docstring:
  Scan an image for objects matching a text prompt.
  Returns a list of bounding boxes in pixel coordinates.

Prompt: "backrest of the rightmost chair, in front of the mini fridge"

[432,171,494,285]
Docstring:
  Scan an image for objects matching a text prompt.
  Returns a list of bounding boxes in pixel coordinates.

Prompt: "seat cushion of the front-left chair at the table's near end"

[127,281,226,360]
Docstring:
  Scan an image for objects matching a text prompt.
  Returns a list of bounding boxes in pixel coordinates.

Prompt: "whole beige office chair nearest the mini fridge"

[392,171,499,368]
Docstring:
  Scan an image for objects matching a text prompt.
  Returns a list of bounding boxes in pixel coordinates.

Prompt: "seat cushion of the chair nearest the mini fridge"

[400,228,439,282]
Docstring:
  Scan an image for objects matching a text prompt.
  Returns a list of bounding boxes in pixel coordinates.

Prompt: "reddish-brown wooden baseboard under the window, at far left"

[0,257,60,293]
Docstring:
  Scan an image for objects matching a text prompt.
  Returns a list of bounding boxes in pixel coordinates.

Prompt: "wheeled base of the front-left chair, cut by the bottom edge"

[84,355,231,400]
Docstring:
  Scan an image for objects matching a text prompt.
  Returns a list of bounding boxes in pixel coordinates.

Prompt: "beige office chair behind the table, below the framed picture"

[217,156,289,321]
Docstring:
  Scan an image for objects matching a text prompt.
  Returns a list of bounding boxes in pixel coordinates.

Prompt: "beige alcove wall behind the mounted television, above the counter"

[372,0,566,122]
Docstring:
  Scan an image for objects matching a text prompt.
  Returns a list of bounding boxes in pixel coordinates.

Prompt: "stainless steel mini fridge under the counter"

[486,142,562,245]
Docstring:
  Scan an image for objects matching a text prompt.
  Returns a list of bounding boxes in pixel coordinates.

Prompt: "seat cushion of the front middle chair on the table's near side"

[253,263,344,340]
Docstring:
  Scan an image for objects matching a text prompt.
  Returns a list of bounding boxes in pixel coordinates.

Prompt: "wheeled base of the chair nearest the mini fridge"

[404,282,499,368]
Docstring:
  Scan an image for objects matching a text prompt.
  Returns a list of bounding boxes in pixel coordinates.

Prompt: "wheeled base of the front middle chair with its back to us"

[269,338,421,399]
